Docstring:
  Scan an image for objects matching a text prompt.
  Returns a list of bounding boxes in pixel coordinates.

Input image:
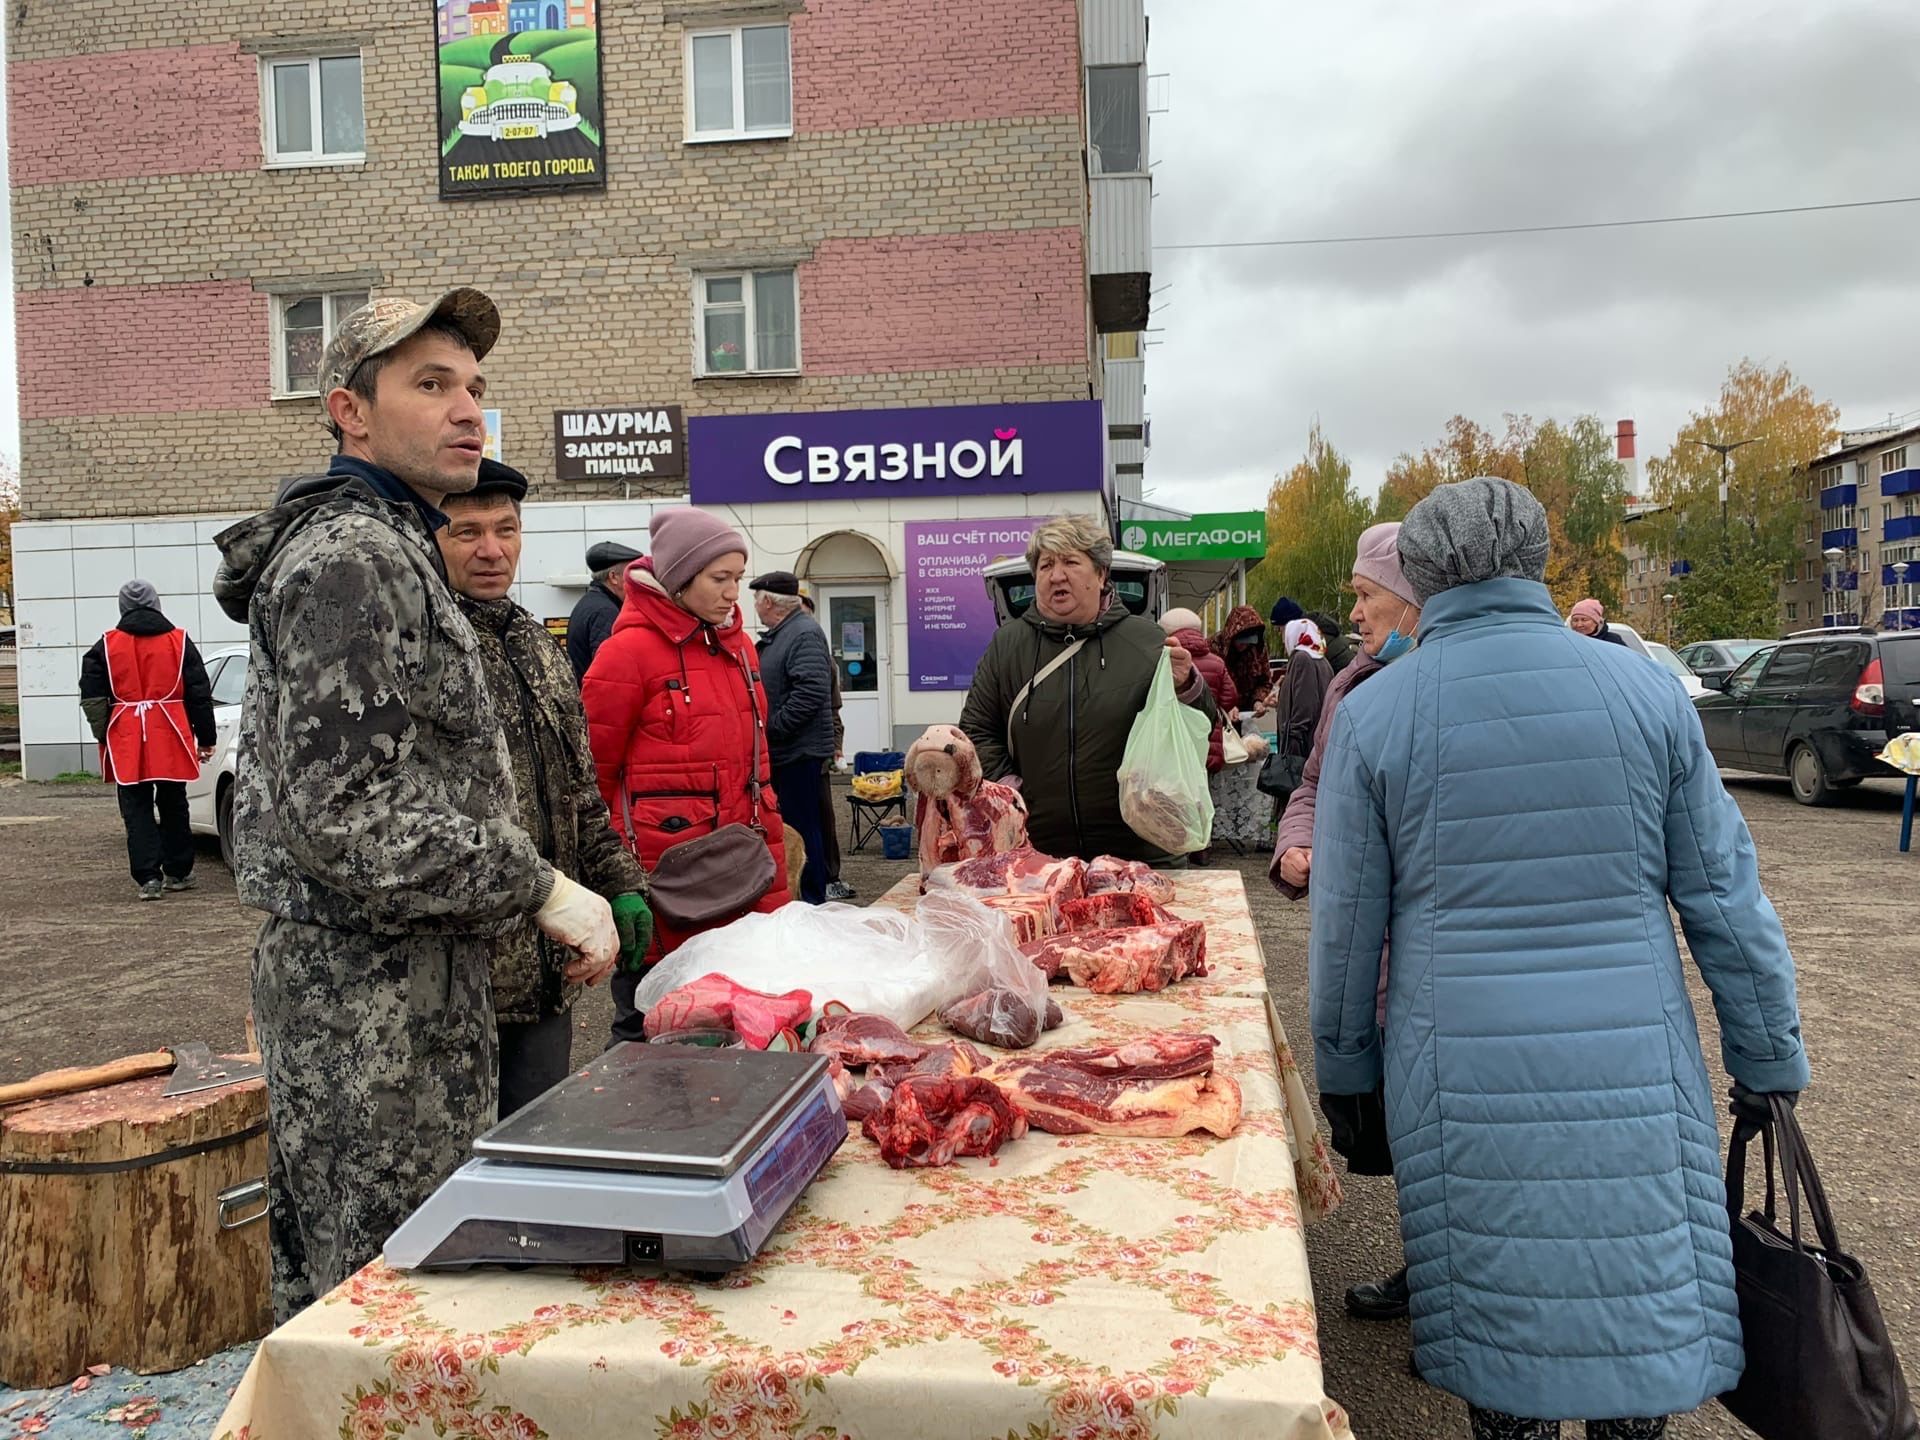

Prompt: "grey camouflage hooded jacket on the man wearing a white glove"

[213,476,553,935]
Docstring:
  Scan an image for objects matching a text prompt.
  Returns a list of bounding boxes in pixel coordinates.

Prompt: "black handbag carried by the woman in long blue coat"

[1720,1094,1920,1440]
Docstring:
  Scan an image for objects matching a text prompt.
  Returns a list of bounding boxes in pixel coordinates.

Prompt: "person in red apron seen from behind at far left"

[81,580,219,900]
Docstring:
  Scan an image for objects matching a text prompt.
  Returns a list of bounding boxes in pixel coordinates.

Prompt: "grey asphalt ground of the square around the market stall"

[0,778,1920,1440]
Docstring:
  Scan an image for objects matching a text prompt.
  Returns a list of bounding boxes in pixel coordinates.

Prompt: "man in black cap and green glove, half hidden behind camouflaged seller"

[438,461,653,1119]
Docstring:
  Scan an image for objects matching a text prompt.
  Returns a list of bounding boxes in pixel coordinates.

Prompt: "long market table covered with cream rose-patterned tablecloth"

[217,874,1352,1440]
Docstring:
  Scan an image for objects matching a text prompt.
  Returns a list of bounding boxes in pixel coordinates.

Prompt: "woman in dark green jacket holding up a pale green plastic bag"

[960,515,1219,864]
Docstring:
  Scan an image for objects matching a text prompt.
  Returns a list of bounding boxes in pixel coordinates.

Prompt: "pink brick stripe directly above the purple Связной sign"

[801,227,1087,374]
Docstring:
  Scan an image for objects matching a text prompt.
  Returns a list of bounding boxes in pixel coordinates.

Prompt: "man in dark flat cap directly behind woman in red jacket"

[747,570,833,904]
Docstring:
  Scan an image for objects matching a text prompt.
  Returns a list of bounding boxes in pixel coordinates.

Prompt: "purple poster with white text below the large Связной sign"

[906,515,1043,689]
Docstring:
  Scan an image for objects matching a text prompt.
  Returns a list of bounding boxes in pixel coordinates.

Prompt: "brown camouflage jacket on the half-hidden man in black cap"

[459,595,647,1021]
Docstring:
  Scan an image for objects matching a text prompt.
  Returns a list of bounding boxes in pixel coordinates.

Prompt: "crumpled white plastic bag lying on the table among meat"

[634,904,960,1029]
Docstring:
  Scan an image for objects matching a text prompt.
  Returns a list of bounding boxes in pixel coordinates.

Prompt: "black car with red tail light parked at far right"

[1693,630,1920,804]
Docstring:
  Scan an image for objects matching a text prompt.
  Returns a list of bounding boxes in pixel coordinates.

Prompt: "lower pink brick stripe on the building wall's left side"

[13,280,271,420]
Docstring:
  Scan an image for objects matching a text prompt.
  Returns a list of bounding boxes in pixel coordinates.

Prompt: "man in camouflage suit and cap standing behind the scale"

[213,290,618,1321]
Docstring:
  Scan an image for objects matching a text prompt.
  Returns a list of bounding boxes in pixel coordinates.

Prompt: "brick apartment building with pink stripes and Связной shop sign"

[6,0,1152,776]
